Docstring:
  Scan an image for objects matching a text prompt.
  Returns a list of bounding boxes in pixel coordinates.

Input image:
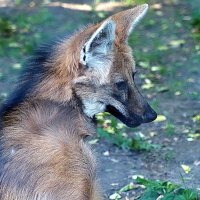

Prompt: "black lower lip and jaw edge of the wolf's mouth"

[106,105,143,128]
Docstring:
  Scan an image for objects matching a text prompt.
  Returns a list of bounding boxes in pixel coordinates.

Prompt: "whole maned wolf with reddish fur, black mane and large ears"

[0,4,156,200]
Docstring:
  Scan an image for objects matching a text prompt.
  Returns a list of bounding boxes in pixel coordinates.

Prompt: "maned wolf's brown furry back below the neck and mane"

[0,101,100,200]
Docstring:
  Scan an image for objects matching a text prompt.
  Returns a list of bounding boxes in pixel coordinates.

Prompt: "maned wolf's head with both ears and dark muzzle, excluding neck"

[72,4,157,127]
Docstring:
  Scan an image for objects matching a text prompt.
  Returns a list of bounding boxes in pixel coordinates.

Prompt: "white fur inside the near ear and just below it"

[80,19,116,84]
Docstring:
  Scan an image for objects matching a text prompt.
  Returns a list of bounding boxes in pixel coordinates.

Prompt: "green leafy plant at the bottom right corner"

[110,176,198,200]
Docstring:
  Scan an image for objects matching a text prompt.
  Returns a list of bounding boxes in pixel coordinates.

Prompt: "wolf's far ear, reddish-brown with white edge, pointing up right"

[111,4,148,42]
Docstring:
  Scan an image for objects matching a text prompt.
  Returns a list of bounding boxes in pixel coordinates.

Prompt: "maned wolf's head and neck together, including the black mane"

[0,4,157,127]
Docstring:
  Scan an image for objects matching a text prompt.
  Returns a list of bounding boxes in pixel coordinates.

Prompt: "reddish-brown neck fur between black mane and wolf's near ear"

[33,24,100,102]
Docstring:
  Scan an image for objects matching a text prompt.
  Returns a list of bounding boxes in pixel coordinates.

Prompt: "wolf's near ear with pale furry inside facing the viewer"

[80,19,115,68]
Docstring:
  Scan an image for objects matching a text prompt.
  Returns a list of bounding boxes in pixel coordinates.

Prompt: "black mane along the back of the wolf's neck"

[0,42,56,118]
